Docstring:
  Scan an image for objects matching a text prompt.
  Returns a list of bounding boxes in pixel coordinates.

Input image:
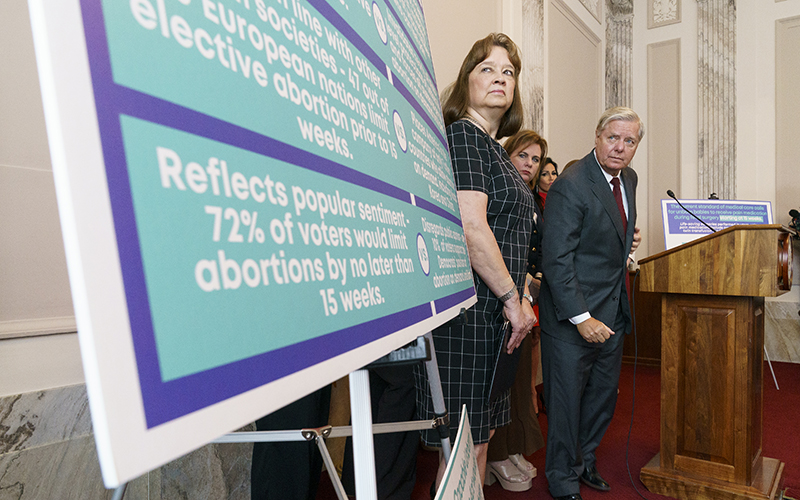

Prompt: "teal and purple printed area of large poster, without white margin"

[90,0,474,426]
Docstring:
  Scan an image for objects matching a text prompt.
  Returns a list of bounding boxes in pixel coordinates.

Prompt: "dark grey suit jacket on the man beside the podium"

[539,148,638,347]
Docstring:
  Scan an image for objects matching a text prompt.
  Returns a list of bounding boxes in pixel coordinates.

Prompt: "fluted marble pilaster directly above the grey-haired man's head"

[606,0,633,108]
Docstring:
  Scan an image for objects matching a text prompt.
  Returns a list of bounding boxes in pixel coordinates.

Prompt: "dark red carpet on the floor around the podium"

[317,363,800,500]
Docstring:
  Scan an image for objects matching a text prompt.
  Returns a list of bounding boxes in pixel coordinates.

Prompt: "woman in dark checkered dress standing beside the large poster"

[418,33,535,490]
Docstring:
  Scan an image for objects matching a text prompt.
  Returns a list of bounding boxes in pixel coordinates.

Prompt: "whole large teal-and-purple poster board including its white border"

[30,0,475,487]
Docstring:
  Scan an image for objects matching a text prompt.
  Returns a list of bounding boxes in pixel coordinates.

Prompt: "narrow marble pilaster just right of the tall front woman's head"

[520,0,544,132]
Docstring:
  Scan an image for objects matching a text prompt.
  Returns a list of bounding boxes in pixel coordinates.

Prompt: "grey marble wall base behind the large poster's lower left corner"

[0,385,254,500]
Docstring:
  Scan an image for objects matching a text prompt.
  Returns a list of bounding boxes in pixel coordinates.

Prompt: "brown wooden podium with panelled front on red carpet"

[639,225,792,500]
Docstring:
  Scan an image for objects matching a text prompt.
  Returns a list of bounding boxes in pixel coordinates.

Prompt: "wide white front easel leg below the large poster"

[349,368,378,500]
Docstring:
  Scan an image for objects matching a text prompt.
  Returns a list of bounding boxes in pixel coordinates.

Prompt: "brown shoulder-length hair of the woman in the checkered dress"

[442,33,523,139]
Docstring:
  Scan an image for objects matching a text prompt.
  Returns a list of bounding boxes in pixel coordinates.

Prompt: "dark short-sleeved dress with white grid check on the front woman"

[417,120,535,446]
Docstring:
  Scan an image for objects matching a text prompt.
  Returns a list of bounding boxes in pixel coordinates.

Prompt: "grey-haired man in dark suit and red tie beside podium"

[539,107,644,500]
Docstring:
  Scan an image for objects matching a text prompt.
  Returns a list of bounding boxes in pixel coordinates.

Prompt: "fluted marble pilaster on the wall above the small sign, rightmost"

[697,0,736,200]
